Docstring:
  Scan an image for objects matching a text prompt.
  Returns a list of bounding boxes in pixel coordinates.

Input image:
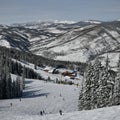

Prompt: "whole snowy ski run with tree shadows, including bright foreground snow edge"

[0,79,120,120]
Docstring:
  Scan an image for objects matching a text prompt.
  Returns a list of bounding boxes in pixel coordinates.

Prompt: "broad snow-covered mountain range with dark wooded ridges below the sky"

[0,20,120,62]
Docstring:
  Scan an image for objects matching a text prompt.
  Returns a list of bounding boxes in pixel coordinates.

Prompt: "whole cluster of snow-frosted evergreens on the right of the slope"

[79,57,120,110]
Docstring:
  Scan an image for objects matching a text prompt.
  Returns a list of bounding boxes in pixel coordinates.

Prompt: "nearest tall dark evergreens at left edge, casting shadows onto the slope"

[0,55,24,99]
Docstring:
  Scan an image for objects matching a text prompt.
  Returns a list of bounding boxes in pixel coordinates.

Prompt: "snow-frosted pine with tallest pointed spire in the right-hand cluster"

[97,56,114,108]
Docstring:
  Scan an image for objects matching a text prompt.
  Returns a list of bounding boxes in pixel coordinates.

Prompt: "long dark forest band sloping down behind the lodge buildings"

[0,47,87,75]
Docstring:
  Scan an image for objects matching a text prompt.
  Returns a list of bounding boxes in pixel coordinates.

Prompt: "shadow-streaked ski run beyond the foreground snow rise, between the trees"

[0,79,79,120]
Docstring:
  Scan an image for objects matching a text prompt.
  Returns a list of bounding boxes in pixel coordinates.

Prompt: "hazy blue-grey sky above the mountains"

[0,0,120,24]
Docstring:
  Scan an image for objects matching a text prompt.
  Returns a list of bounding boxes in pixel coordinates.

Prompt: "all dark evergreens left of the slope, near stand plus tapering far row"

[0,55,41,99]
